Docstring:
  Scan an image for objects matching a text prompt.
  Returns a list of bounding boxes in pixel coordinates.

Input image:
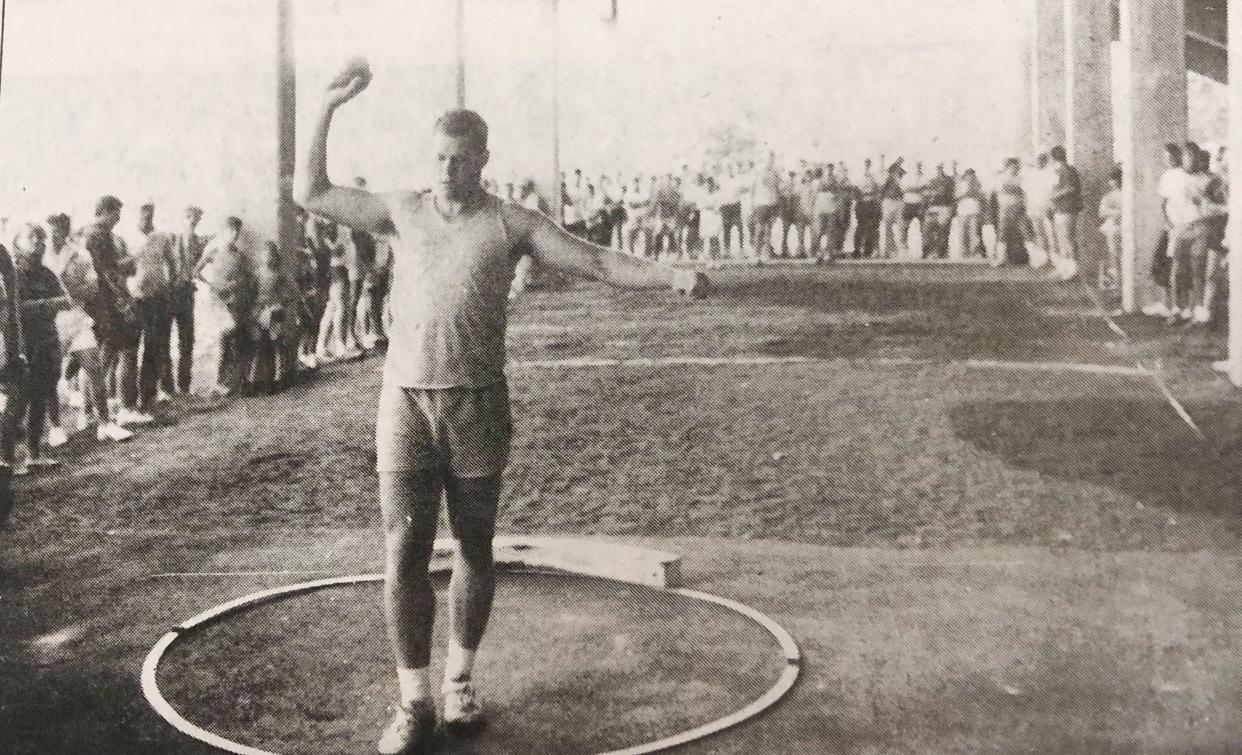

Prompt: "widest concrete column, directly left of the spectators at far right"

[1118,0,1187,312]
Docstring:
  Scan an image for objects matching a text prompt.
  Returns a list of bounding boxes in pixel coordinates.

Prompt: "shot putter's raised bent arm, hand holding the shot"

[297,57,392,233]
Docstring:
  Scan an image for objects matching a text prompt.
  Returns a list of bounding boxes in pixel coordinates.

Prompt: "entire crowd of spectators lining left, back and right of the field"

[0,143,1228,514]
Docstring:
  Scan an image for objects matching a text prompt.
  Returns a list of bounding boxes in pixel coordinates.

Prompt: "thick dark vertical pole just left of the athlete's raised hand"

[276,0,301,260]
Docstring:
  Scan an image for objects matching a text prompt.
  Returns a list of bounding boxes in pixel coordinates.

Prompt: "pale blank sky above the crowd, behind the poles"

[0,0,1026,229]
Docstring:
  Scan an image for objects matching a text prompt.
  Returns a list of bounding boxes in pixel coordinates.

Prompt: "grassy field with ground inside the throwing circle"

[0,267,1242,754]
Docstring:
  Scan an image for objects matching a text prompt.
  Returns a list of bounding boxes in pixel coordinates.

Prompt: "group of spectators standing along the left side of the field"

[0,179,391,496]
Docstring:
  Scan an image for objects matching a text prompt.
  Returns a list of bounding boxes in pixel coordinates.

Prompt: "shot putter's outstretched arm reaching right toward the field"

[512,207,708,298]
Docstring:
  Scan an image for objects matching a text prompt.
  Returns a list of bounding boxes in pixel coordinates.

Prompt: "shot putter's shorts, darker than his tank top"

[375,382,513,479]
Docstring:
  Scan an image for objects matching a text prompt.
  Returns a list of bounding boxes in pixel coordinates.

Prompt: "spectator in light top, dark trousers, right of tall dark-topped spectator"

[128,204,176,412]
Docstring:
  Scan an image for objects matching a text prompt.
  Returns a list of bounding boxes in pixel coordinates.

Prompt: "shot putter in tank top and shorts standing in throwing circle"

[298,58,707,753]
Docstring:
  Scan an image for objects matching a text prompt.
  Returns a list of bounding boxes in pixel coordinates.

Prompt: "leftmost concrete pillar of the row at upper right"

[1031,0,1066,150]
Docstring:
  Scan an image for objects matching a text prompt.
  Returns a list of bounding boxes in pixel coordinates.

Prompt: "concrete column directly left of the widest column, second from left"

[1064,0,1113,278]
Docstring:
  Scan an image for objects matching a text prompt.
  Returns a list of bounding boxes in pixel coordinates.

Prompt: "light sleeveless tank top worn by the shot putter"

[384,192,517,389]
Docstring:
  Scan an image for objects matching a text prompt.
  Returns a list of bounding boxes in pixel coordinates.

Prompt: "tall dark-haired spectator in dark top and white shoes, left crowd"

[83,196,152,432]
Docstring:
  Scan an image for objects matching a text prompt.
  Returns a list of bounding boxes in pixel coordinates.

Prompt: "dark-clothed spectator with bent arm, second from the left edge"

[14,225,71,467]
